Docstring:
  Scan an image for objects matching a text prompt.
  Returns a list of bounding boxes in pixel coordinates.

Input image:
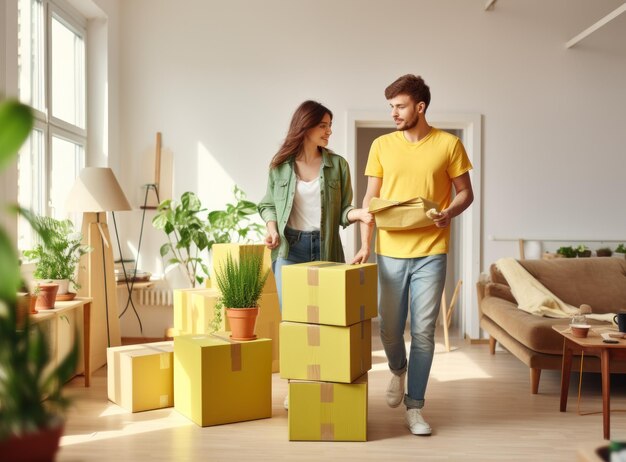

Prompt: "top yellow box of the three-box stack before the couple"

[283,261,378,326]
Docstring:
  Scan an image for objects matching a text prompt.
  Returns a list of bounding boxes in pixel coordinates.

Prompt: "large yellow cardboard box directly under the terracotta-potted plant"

[174,332,272,427]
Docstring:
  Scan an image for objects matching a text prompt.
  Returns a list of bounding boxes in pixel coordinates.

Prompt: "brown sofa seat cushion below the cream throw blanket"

[480,296,608,355]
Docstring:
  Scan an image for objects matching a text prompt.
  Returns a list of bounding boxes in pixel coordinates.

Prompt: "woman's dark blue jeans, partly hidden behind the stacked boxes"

[272,227,320,312]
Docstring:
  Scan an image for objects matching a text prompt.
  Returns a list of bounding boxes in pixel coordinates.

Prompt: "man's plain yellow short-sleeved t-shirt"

[365,127,472,258]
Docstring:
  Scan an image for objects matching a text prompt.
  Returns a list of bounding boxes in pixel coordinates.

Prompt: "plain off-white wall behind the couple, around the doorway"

[112,0,626,278]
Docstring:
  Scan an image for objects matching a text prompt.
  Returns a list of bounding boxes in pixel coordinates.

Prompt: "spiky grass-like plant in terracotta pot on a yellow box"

[215,253,270,340]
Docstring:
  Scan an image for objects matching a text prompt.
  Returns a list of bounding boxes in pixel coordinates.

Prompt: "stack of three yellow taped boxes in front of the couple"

[280,262,378,441]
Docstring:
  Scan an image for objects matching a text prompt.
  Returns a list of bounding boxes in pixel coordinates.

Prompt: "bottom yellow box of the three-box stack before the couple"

[288,374,367,441]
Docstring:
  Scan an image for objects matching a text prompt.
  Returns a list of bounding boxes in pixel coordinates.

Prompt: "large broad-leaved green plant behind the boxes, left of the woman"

[152,186,262,287]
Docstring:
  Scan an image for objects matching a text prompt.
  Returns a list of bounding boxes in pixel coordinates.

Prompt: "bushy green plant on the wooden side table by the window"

[24,215,91,295]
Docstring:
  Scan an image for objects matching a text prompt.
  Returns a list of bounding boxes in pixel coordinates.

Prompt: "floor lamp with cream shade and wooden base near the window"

[67,167,131,370]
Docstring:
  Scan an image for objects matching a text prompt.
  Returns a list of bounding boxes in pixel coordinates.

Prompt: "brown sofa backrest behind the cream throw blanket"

[520,257,626,313]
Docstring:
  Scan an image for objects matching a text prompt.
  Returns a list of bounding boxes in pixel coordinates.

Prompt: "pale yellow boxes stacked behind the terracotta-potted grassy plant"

[169,243,280,372]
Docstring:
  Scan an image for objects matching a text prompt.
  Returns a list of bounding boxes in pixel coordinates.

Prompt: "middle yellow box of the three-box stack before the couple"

[280,320,372,383]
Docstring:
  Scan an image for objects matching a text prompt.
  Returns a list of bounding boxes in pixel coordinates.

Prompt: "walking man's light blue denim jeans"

[377,254,447,409]
